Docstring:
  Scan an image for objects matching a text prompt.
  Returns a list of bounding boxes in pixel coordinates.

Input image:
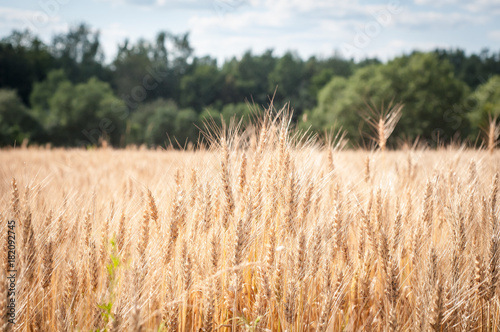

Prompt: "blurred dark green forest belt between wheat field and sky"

[0,24,500,147]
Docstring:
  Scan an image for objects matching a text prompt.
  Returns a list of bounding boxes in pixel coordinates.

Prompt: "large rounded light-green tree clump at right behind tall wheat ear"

[302,52,470,145]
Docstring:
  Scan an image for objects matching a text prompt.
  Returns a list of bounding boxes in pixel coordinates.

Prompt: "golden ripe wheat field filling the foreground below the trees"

[0,113,500,331]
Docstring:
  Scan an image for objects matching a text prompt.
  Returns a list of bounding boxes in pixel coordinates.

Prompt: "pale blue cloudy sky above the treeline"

[0,0,500,63]
